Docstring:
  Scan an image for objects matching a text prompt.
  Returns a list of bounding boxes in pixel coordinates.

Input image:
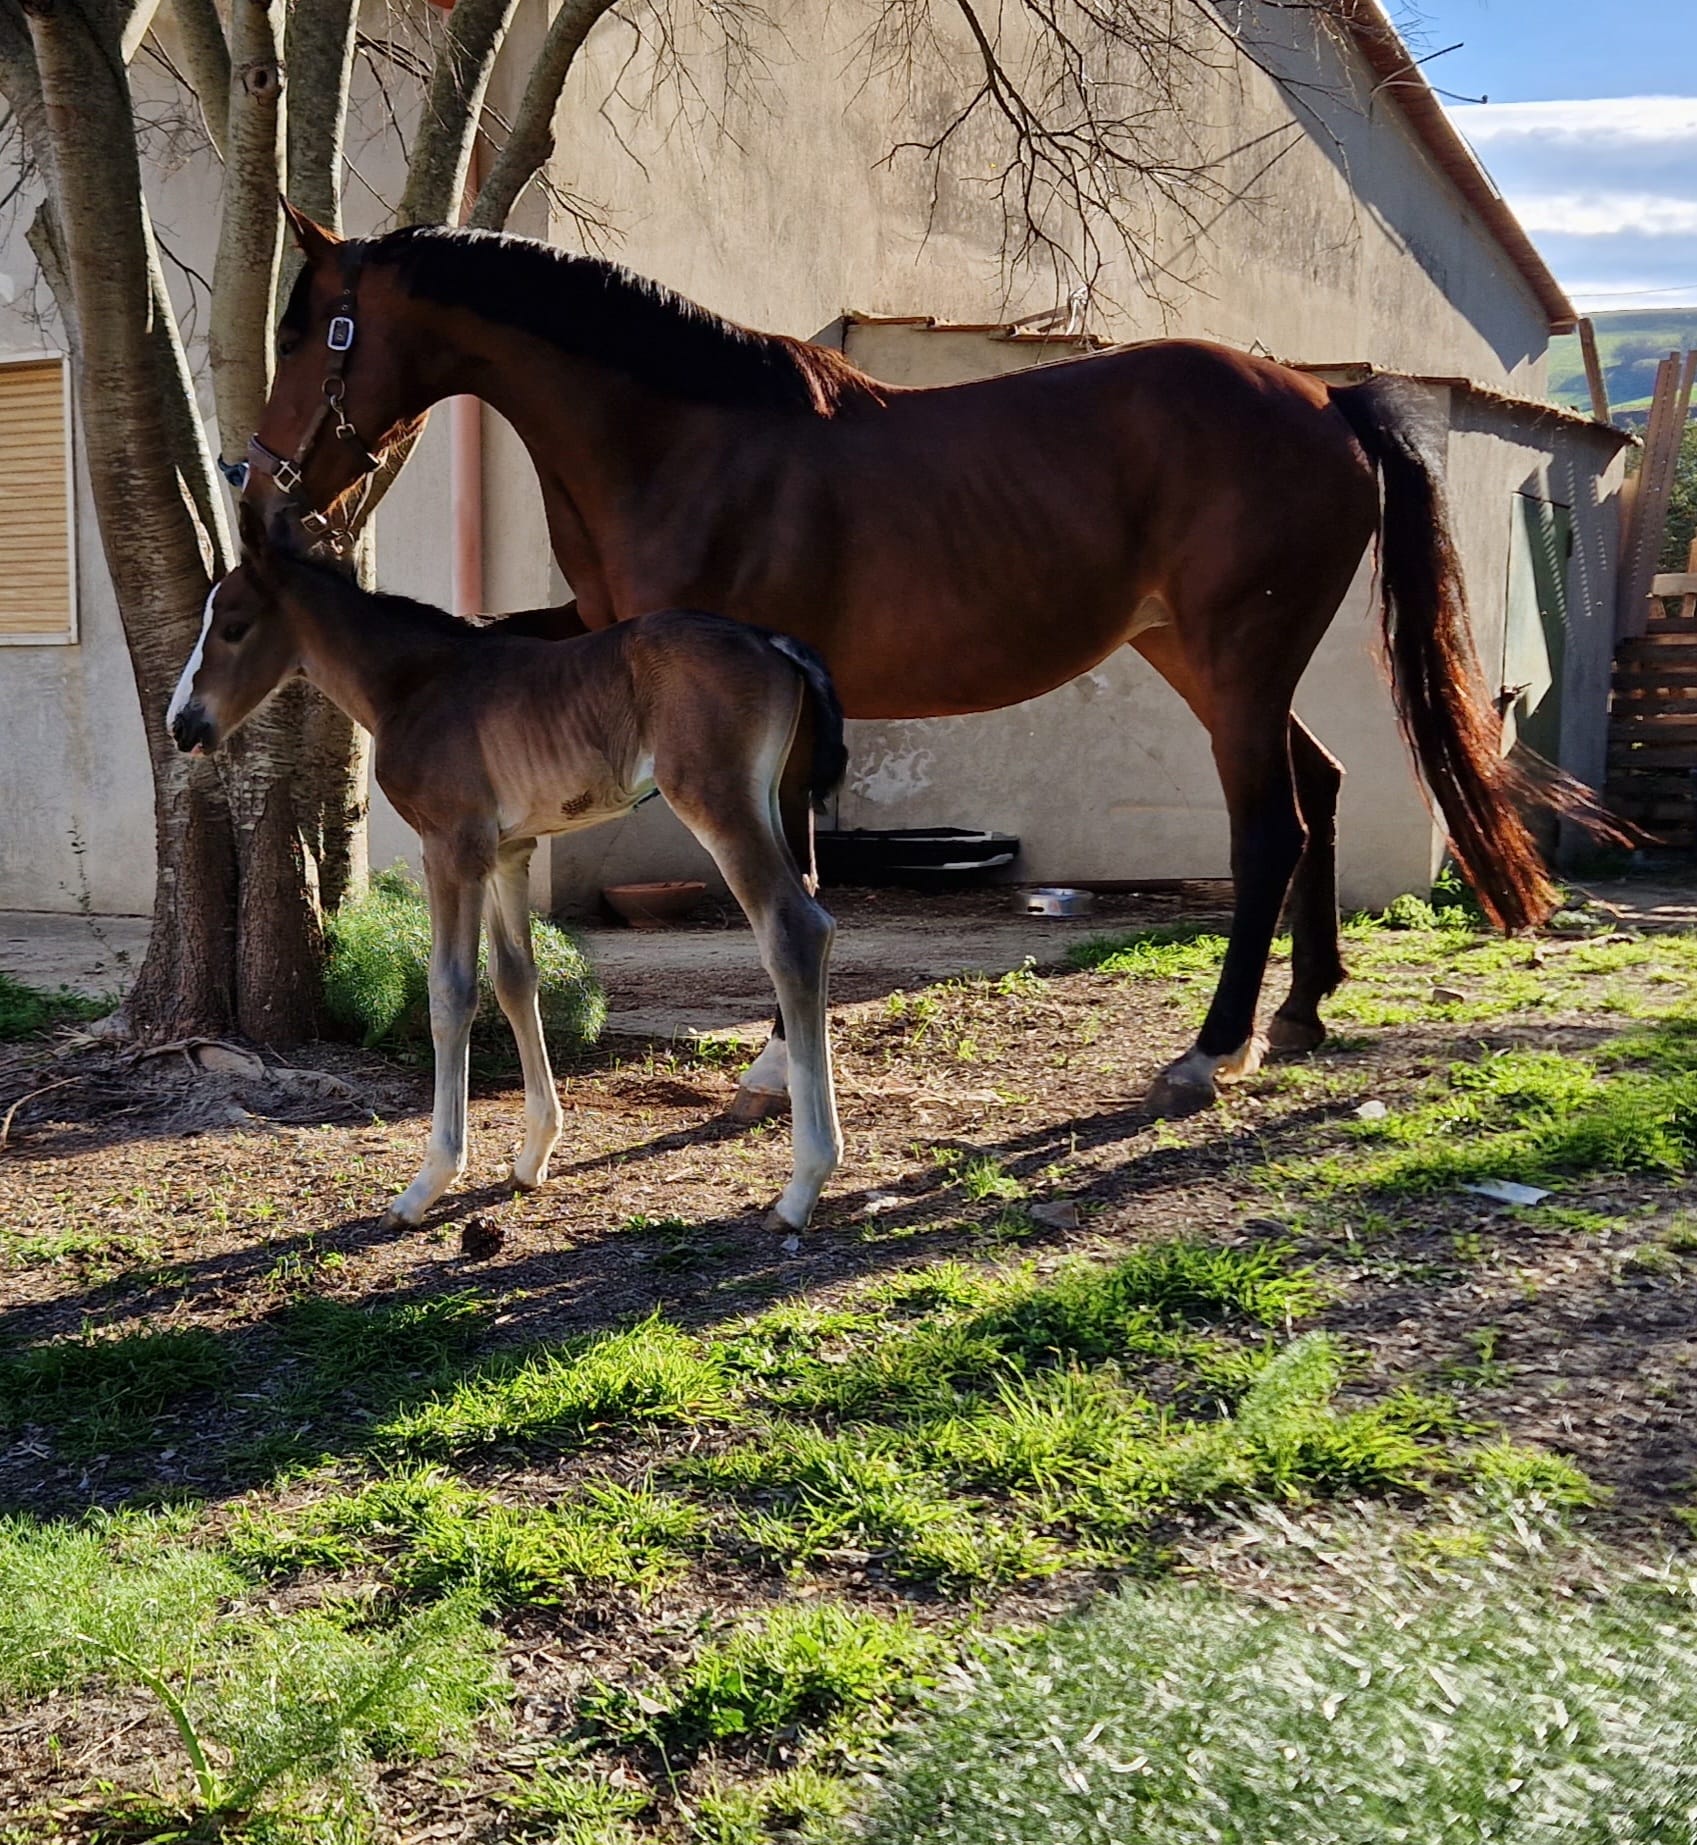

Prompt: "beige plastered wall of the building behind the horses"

[0,0,1578,911]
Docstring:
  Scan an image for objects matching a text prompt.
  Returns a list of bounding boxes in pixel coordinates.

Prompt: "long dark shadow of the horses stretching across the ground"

[0,1077,1364,1517]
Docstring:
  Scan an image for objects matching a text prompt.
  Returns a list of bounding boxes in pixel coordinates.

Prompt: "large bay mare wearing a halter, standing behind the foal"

[247,210,1588,1111]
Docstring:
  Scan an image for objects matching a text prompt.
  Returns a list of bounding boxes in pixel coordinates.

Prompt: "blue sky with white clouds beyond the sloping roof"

[1396,0,1697,312]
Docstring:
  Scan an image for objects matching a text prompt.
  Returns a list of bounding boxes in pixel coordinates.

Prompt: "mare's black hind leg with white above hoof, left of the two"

[1149,697,1304,1114]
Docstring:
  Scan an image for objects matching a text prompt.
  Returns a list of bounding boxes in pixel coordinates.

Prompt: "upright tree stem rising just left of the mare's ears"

[207,0,282,454]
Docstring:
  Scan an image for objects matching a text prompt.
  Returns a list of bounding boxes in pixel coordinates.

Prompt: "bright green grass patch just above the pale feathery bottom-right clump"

[673,1334,1444,1589]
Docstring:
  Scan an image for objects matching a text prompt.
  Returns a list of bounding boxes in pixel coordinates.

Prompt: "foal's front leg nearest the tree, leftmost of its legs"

[384,839,487,1225]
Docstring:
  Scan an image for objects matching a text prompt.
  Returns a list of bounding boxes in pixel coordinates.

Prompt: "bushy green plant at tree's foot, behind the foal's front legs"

[325,871,607,1063]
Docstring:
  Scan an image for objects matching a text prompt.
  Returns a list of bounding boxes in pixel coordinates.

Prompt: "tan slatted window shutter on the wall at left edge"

[0,358,76,644]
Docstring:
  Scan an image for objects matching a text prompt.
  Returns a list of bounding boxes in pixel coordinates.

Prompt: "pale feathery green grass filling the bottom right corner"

[863,1531,1697,1845]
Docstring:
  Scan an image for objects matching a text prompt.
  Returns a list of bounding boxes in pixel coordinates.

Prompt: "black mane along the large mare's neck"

[362,225,882,415]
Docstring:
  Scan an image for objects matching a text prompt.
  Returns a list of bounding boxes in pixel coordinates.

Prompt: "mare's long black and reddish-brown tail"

[1332,380,1631,930]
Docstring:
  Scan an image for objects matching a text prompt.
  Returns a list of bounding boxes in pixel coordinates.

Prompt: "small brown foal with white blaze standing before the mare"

[166,507,845,1229]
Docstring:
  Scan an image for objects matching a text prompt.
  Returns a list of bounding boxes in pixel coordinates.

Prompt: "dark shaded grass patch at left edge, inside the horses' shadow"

[0,1327,231,1456]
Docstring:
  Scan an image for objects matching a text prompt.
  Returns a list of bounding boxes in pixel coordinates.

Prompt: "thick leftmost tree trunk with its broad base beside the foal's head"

[30,0,317,1037]
